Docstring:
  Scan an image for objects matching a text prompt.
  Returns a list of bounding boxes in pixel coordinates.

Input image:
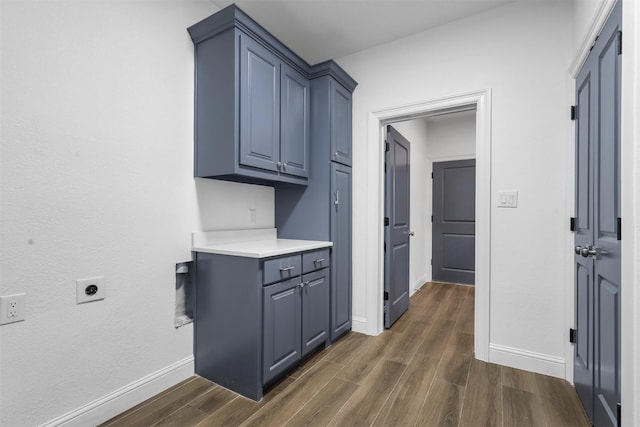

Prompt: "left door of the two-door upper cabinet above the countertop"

[240,34,280,171]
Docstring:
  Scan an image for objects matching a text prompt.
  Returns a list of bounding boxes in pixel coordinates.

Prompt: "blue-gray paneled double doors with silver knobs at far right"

[574,2,622,426]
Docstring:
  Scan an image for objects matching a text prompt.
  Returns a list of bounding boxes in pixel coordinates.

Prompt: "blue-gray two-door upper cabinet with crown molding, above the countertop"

[188,5,311,185]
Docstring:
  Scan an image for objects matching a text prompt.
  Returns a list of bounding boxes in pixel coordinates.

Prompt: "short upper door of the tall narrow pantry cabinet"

[330,80,352,166]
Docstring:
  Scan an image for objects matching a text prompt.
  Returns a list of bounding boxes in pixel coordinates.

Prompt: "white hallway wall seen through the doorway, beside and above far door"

[393,111,476,294]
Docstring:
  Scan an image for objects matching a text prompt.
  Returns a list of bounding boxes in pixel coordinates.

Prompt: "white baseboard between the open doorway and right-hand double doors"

[489,344,565,379]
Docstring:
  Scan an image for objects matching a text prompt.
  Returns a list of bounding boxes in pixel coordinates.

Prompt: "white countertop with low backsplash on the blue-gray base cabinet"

[191,228,333,258]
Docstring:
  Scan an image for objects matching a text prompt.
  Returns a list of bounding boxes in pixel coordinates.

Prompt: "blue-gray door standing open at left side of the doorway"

[384,126,413,328]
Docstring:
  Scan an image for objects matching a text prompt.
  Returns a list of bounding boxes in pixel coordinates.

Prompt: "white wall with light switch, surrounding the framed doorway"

[338,2,573,375]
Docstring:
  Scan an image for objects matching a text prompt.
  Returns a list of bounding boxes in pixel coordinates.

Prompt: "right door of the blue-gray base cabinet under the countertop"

[302,268,329,356]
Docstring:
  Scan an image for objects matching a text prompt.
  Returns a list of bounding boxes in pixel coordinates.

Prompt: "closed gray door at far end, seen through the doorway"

[432,159,476,285]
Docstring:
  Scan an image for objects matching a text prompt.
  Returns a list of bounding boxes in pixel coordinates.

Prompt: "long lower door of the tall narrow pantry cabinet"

[330,162,351,341]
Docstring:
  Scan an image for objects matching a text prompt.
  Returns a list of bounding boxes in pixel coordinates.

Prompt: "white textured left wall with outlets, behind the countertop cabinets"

[0,1,273,426]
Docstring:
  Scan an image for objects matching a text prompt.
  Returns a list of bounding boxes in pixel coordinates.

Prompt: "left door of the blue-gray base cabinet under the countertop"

[262,277,302,384]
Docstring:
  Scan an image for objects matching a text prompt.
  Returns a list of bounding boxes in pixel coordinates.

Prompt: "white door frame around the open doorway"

[362,88,491,361]
